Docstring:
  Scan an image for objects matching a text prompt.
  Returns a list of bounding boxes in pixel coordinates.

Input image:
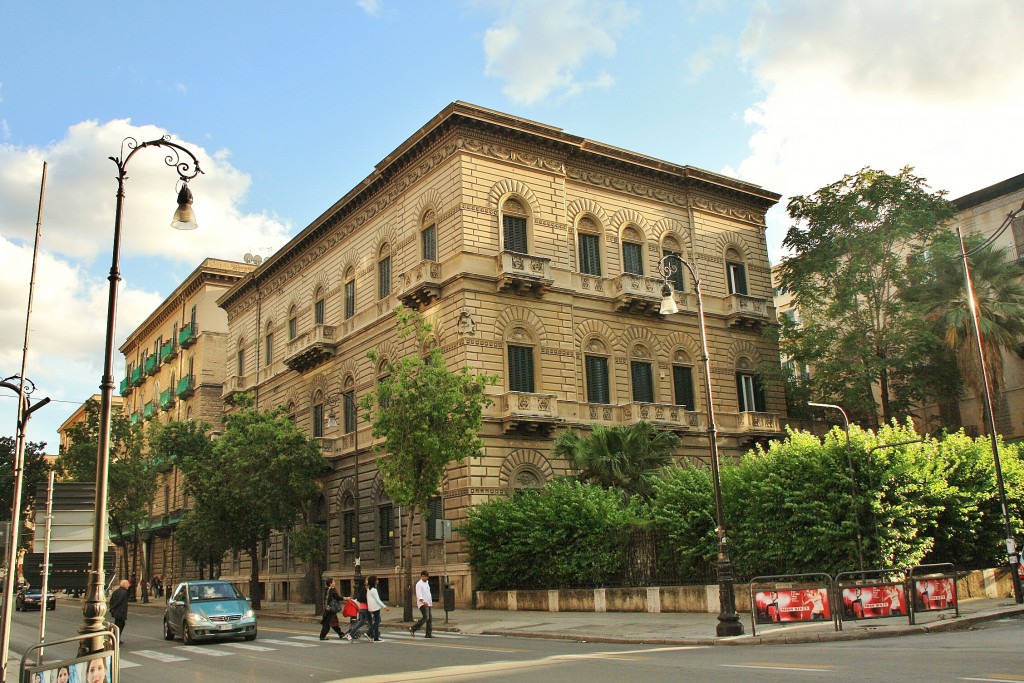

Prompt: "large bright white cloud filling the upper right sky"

[728,0,1024,260]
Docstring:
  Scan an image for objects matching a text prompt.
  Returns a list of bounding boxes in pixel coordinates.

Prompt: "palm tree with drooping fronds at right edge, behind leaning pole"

[911,229,1024,405]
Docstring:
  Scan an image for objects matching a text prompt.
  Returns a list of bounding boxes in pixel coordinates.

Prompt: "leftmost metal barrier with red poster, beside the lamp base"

[750,573,839,636]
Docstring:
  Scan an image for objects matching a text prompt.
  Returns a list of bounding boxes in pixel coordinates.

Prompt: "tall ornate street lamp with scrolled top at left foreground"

[79,135,203,654]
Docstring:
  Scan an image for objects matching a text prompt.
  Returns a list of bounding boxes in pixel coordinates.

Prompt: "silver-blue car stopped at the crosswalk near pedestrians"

[164,581,256,645]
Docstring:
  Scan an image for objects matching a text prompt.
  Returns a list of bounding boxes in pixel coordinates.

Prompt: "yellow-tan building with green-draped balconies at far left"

[117,258,254,587]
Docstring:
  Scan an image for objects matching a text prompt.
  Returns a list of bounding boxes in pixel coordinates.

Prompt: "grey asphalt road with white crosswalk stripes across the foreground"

[8,604,1024,683]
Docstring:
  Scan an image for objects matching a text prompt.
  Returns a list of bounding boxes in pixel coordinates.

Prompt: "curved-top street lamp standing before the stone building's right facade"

[657,254,743,637]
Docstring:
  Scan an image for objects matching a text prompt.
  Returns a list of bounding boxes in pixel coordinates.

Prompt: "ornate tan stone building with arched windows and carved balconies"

[219,102,784,606]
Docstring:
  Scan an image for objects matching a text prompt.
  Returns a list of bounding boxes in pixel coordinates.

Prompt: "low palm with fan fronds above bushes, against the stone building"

[552,422,680,498]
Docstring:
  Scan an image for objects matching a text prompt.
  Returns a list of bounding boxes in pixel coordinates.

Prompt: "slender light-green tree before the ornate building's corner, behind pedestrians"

[360,306,497,621]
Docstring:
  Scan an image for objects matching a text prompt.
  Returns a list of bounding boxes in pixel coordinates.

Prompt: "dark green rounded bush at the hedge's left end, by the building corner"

[460,481,640,590]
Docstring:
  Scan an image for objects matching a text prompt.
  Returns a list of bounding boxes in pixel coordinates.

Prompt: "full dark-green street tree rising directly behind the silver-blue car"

[177,394,330,609]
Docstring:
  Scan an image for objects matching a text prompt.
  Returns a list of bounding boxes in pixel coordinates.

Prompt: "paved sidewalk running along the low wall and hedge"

[123,598,1024,645]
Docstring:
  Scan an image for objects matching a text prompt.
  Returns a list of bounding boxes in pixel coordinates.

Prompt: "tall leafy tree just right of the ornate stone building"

[780,168,956,424]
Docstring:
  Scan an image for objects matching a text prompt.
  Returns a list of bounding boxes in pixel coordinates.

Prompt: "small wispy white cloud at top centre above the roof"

[483,0,637,104]
